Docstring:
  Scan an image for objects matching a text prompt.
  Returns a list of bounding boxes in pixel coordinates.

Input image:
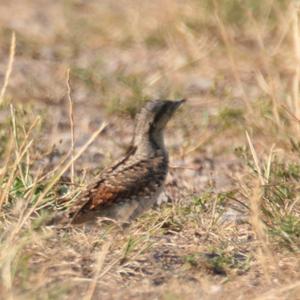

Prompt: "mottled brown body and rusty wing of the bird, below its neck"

[70,146,168,223]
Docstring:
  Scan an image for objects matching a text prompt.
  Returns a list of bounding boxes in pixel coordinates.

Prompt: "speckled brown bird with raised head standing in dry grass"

[54,99,186,224]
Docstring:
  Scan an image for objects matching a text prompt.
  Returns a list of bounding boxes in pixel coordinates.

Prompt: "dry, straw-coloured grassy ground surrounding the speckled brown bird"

[0,0,300,300]
